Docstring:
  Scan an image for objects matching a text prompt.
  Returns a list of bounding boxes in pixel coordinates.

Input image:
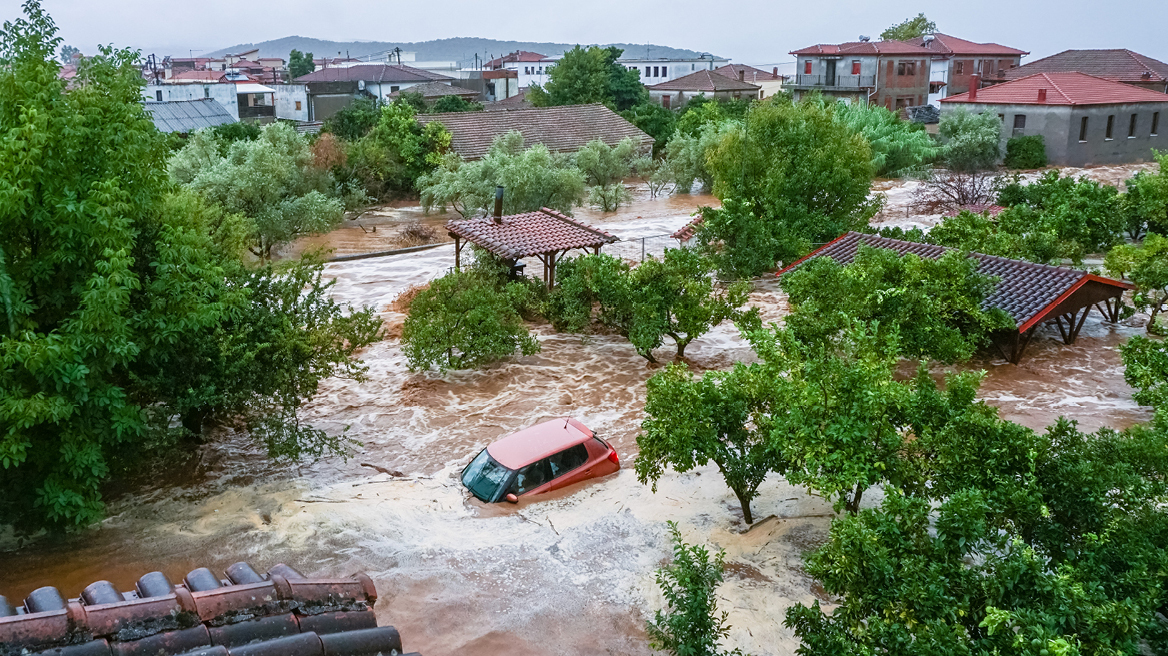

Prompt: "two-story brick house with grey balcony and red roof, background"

[788,40,932,110]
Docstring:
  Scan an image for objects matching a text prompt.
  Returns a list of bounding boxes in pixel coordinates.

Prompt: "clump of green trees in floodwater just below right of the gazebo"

[550,249,753,362]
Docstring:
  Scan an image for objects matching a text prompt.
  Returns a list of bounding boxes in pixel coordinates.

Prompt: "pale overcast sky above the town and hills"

[11,0,1168,64]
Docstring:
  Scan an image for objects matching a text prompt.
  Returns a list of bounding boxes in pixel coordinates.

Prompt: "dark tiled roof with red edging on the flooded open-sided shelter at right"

[778,232,1132,333]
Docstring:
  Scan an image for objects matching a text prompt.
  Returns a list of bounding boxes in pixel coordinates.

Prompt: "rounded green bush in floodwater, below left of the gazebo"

[402,271,540,374]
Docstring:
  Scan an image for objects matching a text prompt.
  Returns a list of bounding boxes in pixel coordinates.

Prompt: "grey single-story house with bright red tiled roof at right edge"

[940,72,1168,166]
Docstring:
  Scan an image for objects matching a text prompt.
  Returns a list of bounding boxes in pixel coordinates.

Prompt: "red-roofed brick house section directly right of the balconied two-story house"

[911,33,1029,106]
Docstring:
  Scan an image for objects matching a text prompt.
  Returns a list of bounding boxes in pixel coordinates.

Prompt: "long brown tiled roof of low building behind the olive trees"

[417,105,653,160]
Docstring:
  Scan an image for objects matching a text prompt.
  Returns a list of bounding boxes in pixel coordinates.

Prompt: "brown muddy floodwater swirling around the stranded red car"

[0,167,1149,656]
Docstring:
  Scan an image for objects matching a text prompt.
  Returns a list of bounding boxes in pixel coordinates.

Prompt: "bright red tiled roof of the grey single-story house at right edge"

[941,72,1168,105]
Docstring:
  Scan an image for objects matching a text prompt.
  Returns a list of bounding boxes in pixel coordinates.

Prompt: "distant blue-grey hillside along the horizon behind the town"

[203,36,702,65]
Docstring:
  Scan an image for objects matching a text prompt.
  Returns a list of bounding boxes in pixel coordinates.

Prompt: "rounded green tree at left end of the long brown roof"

[348,102,451,198]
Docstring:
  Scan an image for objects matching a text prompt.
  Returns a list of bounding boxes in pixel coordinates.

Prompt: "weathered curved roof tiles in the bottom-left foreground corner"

[0,555,420,656]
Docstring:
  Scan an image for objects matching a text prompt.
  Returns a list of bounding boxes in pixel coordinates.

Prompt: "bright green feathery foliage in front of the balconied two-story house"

[834,103,940,177]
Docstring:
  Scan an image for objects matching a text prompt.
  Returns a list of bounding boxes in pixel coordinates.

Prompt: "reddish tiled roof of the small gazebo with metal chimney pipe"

[446,208,618,259]
